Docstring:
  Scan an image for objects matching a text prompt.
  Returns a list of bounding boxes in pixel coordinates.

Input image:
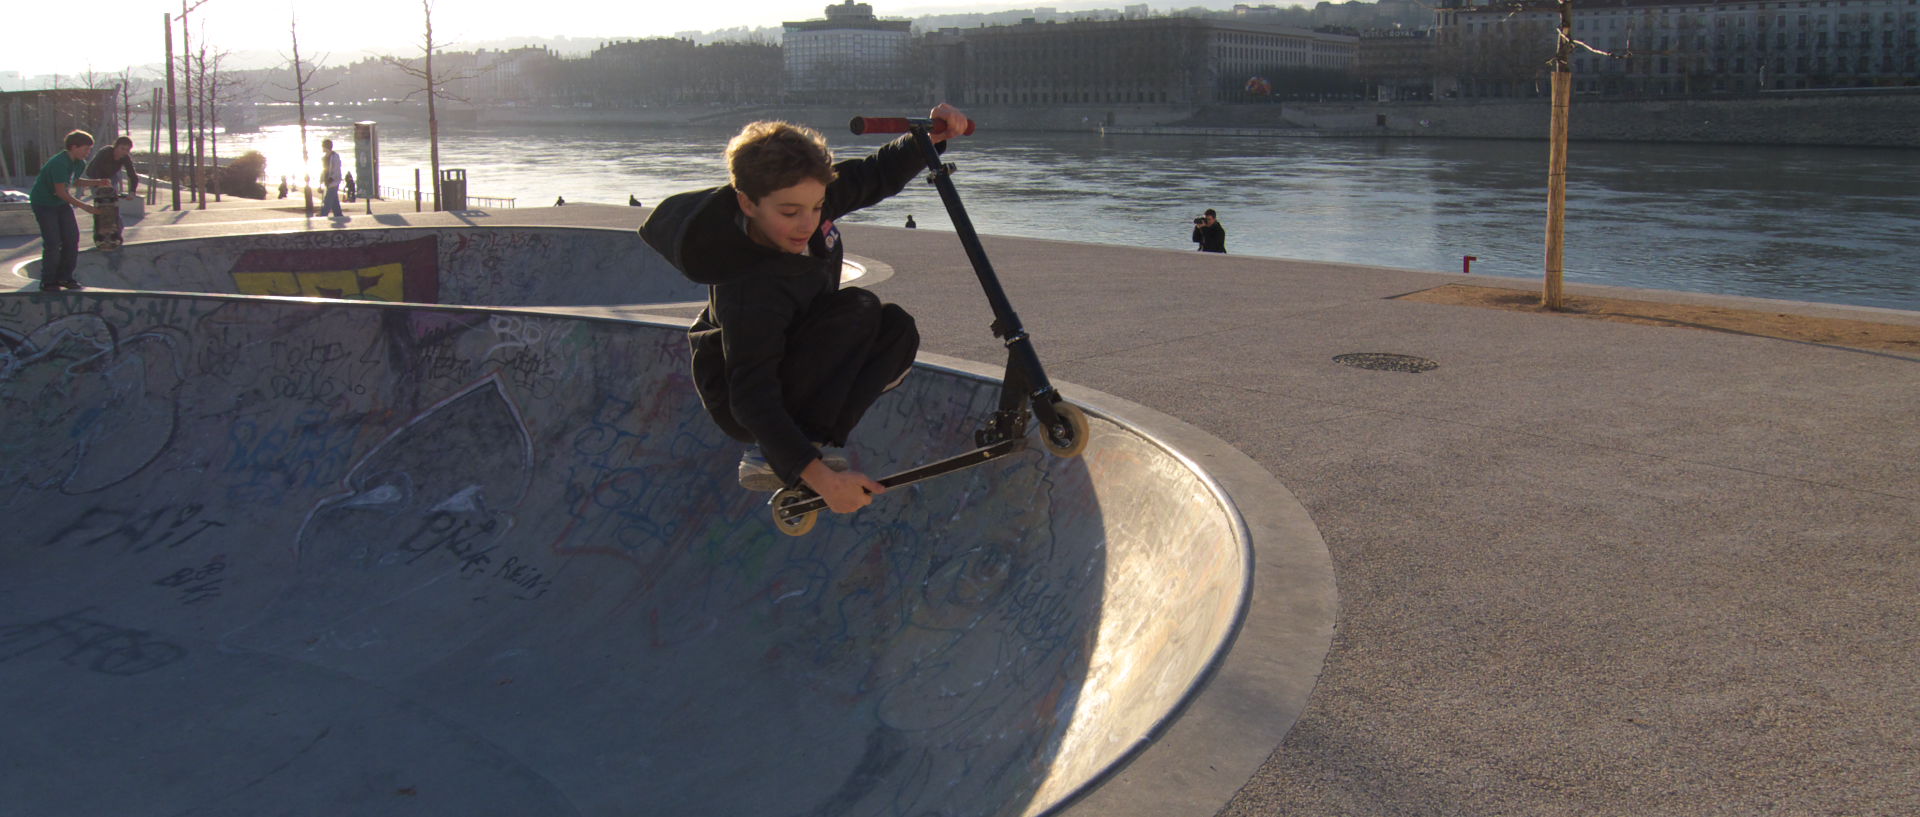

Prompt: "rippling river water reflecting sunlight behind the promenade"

[145,123,1920,309]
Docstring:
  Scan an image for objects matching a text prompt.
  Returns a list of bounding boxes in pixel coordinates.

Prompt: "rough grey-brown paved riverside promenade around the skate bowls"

[0,203,1920,815]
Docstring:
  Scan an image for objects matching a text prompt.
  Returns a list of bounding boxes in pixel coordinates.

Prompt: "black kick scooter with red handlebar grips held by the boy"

[768,117,1089,537]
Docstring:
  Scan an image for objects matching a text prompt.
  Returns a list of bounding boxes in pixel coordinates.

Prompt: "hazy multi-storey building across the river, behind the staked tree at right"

[1436,0,1920,96]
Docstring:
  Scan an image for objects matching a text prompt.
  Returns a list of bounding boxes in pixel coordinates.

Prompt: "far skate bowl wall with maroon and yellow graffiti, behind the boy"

[15,226,721,307]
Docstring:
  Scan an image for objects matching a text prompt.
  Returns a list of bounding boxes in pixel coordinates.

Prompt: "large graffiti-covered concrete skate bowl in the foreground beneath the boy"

[0,293,1331,817]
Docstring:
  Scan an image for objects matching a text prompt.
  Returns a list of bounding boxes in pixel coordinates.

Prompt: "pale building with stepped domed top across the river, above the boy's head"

[781,0,918,102]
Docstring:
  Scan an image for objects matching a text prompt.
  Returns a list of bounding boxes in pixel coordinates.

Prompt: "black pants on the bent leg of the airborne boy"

[780,288,920,445]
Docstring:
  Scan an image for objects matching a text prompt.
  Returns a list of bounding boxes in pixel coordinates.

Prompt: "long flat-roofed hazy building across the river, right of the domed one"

[927,17,1357,105]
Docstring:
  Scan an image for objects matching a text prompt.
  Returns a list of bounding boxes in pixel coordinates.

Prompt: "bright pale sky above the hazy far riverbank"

[0,0,1228,81]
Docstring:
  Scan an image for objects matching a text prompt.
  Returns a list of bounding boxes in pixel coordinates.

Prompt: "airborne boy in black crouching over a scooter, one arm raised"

[639,104,968,514]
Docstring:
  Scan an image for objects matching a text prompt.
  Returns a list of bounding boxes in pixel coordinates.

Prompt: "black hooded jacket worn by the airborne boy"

[639,136,947,485]
